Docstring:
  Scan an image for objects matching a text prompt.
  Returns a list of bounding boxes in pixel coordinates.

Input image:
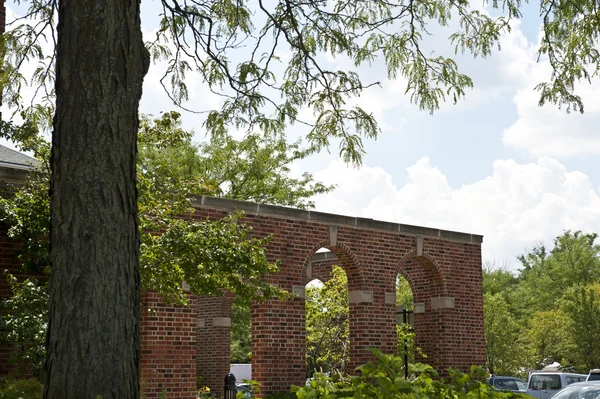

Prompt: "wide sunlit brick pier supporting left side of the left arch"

[252,298,306,394]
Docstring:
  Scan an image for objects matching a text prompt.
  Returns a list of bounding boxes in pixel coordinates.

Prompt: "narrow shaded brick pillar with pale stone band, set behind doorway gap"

[196,297,233,398]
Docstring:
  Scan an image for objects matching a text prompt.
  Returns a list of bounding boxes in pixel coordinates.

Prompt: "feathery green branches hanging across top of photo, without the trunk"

[0,0,600,164]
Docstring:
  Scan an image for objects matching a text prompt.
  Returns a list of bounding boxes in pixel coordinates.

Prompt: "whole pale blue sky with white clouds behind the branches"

[5,0,600,269]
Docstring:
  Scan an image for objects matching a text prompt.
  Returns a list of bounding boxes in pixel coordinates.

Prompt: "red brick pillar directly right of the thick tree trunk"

[140,292,198,399]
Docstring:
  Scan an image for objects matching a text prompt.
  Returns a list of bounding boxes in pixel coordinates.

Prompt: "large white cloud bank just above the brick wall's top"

[315,157,600,268]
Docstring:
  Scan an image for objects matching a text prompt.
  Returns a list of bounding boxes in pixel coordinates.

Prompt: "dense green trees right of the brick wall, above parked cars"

[483,231,600,375]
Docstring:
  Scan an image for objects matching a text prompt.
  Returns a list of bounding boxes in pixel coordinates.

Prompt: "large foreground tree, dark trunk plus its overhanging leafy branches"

[0,0,600,399]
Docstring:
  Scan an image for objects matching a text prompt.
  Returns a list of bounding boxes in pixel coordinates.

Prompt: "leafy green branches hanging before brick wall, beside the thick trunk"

[140,215,285,303]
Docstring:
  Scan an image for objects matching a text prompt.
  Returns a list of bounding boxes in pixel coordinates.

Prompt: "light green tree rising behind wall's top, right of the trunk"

[140,111,335,209]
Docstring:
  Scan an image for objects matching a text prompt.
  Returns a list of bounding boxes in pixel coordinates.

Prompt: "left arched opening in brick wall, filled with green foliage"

[305,264,350,378]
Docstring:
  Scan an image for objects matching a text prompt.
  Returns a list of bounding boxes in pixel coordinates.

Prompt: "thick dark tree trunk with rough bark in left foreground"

[44,0,149,399]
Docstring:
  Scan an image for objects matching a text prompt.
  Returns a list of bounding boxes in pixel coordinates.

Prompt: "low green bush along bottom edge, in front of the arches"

[292,350,526,399]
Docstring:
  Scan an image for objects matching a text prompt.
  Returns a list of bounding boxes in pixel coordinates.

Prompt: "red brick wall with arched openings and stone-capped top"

[193,199,485,393]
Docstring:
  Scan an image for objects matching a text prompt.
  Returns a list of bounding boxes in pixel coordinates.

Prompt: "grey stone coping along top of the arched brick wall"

[194,195,483,244]
